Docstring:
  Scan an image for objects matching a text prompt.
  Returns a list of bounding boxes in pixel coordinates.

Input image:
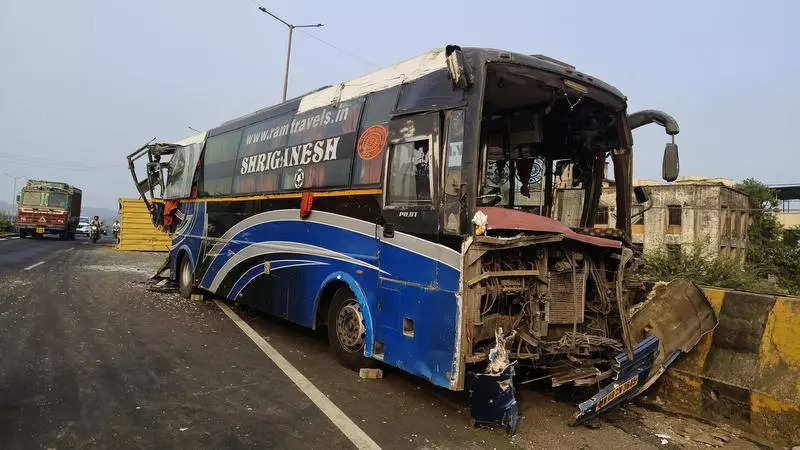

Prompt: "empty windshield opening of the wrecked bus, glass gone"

[478,64,622,218]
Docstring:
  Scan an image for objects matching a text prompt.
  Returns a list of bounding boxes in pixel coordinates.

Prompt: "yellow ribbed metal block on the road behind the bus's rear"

[117,198,171,252]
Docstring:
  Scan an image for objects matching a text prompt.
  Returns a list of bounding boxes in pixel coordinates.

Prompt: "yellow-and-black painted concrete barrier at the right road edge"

[658,288,800,444]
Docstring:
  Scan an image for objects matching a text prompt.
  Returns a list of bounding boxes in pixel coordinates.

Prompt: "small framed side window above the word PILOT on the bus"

[387,139,431,204]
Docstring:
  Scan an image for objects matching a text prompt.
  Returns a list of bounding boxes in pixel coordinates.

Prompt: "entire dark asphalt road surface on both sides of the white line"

[0,238,764,449]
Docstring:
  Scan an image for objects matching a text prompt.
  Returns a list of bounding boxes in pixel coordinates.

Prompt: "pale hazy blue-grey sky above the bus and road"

[0,0,800,208]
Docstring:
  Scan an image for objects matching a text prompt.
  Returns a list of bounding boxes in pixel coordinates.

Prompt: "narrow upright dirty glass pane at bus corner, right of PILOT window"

[443,109,464,233]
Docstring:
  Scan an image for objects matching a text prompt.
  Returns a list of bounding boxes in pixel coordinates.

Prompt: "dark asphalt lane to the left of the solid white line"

[0,241,352,449]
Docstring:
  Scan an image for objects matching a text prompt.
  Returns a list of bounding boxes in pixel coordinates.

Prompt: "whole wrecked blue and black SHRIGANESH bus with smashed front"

[129,45,716,429]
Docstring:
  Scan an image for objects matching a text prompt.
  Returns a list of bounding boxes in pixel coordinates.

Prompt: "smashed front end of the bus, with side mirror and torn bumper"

[450,49,716,422]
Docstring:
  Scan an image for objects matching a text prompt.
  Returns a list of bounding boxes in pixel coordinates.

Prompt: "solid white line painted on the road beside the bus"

[214,300,380,449]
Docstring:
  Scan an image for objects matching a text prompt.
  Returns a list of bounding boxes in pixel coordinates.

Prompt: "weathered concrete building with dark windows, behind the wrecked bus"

[595,177,750,259]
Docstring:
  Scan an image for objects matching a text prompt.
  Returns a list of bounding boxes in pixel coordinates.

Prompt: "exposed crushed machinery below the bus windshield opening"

[462,208,632,386]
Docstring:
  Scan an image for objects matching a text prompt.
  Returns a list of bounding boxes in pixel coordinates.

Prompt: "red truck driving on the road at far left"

[17,180,81,239]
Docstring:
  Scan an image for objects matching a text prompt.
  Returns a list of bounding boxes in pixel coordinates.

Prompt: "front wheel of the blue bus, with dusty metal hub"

[328,286,375,370]
